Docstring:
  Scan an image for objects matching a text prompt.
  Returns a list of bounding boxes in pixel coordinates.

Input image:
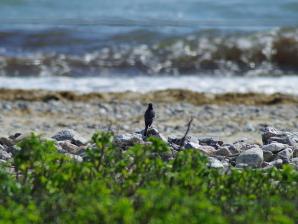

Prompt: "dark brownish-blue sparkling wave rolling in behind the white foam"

[0,28,298,76]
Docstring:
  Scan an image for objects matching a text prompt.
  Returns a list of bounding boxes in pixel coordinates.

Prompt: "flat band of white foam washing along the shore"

[0,76,298,95]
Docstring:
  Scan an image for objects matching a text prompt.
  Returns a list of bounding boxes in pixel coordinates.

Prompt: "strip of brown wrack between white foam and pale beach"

[0,88,298,105]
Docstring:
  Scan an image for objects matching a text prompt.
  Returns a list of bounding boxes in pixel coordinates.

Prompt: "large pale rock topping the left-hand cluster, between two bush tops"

[52,129,88,146]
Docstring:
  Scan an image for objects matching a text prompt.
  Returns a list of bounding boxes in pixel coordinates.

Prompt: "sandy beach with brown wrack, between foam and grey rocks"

[0,89,298,142]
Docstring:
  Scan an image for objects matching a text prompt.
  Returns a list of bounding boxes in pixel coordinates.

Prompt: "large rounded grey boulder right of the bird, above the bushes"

[236,148,264,167]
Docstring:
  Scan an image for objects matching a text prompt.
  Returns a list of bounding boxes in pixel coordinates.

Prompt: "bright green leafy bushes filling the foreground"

[0,133,298,224]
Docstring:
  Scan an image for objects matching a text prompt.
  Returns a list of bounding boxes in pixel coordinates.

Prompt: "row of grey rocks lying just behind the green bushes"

[0,127,298,170]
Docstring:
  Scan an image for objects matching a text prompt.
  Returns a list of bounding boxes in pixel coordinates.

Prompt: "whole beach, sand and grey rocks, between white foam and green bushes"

[0,90,298,169]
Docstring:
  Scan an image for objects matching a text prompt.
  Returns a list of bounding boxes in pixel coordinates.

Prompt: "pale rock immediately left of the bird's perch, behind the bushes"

[114,133,144,149]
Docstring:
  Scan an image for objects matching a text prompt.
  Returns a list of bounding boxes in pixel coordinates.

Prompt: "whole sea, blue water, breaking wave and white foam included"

[0,0,298,95]
